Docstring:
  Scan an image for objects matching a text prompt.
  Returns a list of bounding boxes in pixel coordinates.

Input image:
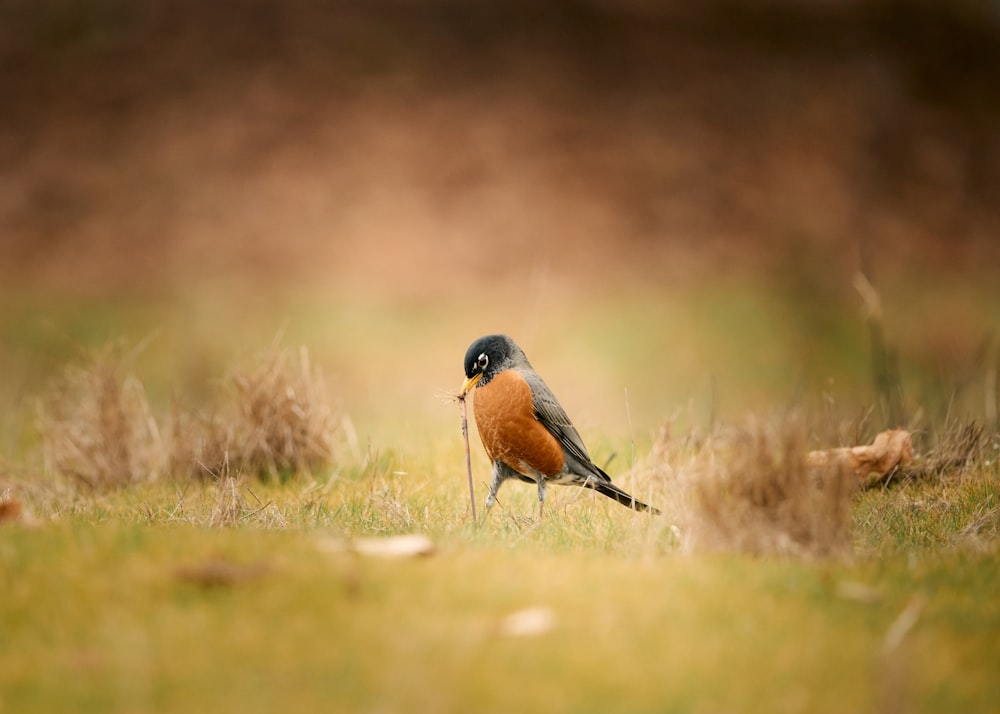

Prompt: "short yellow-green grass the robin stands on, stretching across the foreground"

[0,456,1000,712]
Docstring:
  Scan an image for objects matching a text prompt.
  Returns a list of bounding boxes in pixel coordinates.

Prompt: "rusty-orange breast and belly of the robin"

[473,370,566,477]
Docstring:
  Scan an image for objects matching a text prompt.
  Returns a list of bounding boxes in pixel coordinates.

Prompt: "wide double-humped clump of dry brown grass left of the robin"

[38,344,337,490]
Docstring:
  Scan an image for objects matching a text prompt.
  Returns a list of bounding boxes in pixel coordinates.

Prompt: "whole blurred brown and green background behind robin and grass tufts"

[0,0,1000,450]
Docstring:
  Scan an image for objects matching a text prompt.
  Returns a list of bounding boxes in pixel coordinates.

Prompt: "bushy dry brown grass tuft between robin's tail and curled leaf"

[653,419,857,558]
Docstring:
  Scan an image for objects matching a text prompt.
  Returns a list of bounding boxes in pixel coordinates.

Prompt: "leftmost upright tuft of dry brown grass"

[38,343,162,490]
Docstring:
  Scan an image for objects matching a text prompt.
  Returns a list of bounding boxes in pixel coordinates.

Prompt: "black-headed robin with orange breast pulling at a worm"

[461,335,659,515]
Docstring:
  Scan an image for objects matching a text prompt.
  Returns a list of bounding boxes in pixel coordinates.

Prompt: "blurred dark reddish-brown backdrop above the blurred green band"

[0,0,1000,296]
